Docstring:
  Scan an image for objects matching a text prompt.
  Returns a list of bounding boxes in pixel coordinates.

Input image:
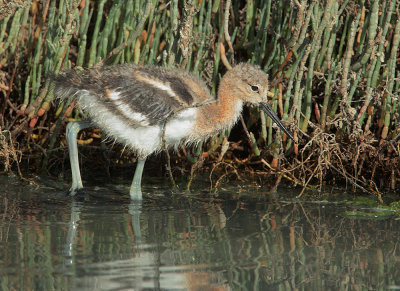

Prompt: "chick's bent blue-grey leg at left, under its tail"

[66,121,92,196]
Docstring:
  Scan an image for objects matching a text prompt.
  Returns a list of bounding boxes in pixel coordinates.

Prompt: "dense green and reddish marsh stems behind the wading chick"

[0,0,400,194]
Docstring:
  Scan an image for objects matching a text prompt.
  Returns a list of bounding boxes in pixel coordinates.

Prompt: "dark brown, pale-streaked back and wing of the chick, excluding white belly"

[53,65,215,127]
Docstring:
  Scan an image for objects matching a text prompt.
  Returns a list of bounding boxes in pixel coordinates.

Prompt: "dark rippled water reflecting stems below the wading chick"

[0,177,400,290]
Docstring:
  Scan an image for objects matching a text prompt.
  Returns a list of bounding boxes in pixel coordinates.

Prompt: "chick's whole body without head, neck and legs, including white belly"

[53,65,216,157]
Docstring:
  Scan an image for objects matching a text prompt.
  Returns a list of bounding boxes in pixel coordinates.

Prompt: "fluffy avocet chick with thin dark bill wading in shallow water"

[54,64,293,200]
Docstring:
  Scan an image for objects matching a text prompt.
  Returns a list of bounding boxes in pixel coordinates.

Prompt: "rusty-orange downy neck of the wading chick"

[197,79,243,136]
